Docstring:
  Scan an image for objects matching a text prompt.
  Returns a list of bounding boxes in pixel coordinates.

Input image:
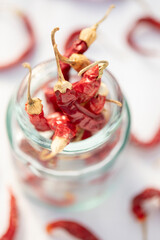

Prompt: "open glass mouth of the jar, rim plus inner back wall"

[15,60,125,155]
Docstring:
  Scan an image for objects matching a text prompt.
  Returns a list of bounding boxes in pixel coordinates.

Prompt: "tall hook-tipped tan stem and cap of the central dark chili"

[51,28,72,93]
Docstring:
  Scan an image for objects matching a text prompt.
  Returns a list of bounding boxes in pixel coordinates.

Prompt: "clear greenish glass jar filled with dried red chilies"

[7,60,130,209]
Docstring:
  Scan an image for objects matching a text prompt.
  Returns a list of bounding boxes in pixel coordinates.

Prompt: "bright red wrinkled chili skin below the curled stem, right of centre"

[73,65,101,103]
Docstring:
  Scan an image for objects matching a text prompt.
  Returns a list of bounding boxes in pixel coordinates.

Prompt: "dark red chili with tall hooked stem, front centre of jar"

[51,28,107,132]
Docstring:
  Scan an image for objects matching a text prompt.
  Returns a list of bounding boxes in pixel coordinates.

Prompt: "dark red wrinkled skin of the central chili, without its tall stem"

[55,89,106,132]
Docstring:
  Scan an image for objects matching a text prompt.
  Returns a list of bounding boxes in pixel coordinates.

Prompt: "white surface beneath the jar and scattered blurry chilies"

[0,0,160,240]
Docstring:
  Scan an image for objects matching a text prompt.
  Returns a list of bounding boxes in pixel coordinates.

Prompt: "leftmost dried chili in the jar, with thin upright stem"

[23,63,50,131]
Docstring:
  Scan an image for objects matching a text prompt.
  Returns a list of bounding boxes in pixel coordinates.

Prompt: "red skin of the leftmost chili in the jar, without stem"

[25,103,50,132]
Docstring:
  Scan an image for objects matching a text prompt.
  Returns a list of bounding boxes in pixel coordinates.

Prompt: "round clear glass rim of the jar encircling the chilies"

[15,59,124,155]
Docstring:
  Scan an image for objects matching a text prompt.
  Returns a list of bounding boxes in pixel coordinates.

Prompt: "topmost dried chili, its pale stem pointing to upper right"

[60,5,114,80]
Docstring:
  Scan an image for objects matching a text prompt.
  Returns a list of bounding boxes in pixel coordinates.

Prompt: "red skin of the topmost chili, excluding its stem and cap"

[60,39,88,81]
